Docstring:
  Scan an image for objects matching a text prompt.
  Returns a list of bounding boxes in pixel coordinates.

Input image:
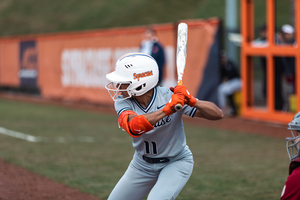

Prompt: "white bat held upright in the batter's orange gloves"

[174,22,188,111]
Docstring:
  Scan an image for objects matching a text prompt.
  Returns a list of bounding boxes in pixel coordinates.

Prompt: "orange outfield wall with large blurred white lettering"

[0,19,219,104]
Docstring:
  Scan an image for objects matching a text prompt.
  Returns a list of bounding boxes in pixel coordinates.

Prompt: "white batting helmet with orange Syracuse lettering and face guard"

[105,53,159,101]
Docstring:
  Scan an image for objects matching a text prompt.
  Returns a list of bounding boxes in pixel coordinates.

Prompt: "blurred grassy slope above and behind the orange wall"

[0,0,290,36]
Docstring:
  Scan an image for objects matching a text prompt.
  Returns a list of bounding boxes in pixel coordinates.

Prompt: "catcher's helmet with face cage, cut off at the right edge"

[286,112,300,161]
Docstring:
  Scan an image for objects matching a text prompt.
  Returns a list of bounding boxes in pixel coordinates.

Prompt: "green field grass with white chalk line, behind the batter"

[0,99,289,200]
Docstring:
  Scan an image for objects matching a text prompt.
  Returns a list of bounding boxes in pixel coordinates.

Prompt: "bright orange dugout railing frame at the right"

[241,0,300,124]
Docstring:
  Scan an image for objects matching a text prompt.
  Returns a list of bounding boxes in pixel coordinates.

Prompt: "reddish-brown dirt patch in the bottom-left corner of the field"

[0,160,99,200]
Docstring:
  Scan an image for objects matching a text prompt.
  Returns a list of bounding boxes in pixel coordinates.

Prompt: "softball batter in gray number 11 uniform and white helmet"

[105,53,223,200]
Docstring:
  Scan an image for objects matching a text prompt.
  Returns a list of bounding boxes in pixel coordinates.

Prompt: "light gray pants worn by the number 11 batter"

[108,146,194,200]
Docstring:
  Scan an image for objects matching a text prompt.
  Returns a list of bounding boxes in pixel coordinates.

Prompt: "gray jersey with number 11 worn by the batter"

[115,86,197,158]
